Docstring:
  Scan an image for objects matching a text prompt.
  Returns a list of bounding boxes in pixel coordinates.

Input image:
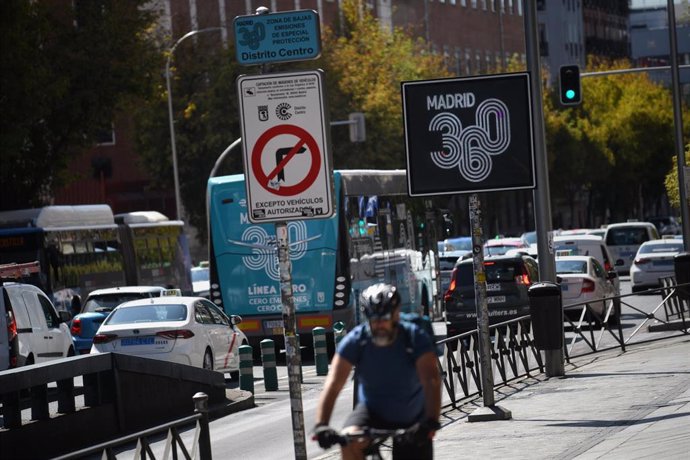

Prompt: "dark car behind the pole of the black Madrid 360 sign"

[444,254,539,337]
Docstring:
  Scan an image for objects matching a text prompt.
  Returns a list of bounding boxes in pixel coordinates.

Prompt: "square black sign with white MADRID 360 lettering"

[402,73,536,196]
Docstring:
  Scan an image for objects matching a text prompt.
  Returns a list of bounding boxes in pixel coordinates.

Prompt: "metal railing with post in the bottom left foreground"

[54,393,211,460]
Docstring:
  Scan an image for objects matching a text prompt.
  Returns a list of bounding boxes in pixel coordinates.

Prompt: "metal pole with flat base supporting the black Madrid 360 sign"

[468,193,512,422]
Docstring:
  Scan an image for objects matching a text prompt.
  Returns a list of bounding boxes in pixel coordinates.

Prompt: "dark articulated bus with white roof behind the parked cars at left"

[0,205,191,310]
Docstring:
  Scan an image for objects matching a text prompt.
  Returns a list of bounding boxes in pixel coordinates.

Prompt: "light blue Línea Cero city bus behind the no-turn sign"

[207,170,442,344]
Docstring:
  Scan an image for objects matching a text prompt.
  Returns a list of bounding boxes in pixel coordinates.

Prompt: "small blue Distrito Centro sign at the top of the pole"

[233,10,321,65]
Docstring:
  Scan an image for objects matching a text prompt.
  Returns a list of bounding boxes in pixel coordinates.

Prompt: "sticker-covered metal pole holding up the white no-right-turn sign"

[275,222,307,460]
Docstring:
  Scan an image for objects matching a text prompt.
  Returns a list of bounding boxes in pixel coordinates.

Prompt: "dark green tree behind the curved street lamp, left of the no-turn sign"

[135,39,246,241]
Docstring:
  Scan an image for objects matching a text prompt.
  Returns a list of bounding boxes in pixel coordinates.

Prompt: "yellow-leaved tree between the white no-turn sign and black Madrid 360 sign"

[321,0,450,168]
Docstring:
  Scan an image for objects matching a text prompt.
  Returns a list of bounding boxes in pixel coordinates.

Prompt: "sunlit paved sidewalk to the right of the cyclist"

[434,336,690,460]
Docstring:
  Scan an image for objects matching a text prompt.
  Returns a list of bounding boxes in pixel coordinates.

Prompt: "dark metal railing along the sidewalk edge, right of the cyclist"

[437,280,690,408]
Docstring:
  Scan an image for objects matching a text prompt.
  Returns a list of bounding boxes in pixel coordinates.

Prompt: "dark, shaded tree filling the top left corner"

[0,0,159,209]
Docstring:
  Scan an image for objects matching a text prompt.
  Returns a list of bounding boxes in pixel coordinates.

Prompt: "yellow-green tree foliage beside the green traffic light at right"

[544,59,687,225]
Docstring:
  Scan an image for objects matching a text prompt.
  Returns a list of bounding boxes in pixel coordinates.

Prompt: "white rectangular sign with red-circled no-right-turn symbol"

[237,70,334,223]
